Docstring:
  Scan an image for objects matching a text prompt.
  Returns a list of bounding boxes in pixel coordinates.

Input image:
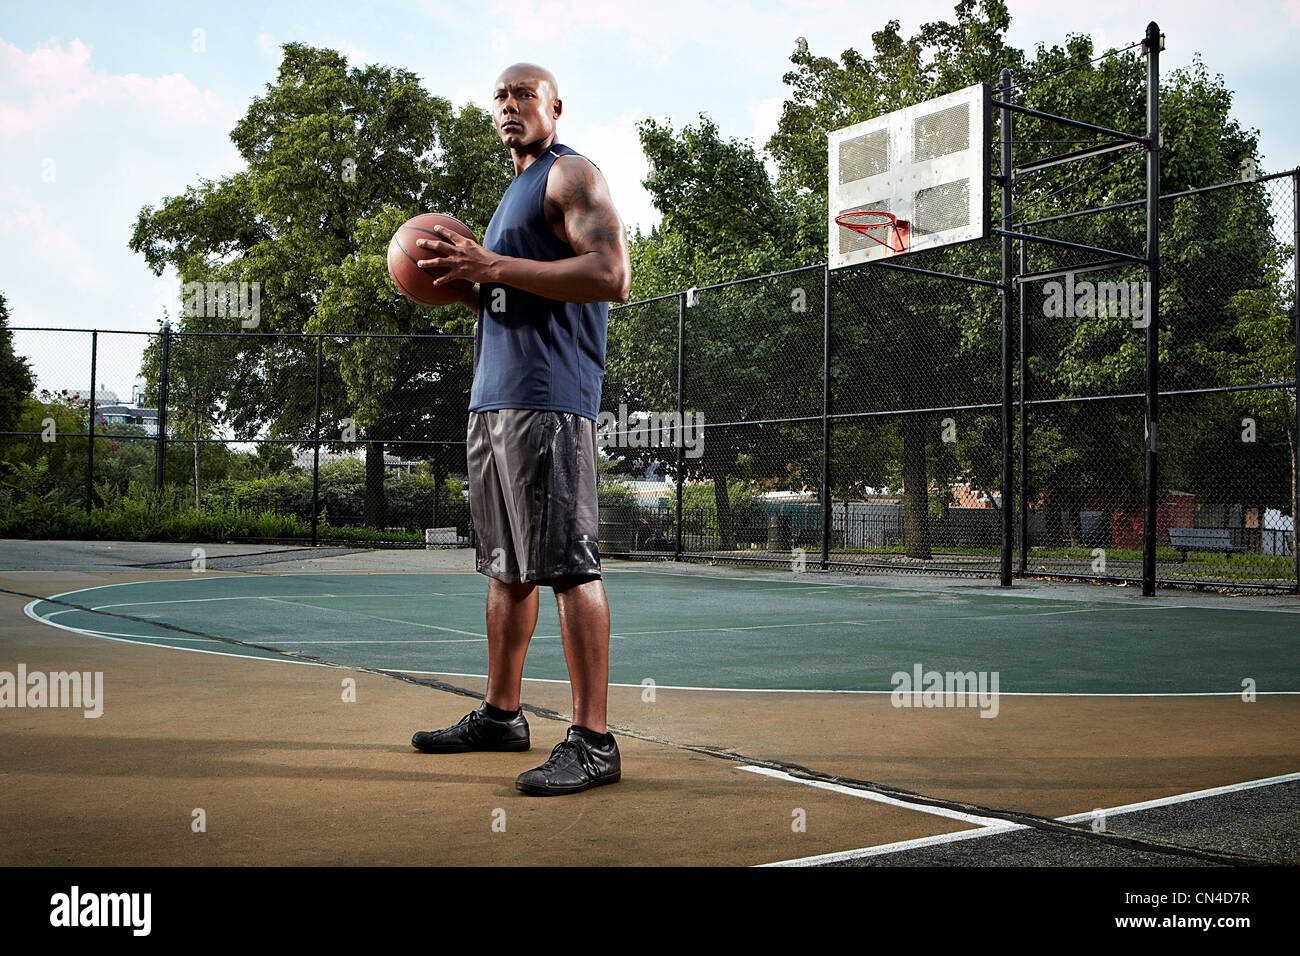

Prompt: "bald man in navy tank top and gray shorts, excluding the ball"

[411,57,632,796]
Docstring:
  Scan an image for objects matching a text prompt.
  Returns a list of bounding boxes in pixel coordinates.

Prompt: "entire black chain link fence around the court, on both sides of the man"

[0,173,1300,588]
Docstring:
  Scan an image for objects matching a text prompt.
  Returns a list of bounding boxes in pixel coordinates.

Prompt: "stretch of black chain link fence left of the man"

[0,329,473,546]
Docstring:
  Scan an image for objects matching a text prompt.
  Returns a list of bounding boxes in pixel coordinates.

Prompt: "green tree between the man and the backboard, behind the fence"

[616,116,824,549]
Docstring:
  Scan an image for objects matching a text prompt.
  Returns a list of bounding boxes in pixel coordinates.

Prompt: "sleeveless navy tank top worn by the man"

[469,143,610,420]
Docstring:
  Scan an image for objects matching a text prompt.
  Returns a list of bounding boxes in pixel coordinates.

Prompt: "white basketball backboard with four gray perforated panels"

[827,83,992,269]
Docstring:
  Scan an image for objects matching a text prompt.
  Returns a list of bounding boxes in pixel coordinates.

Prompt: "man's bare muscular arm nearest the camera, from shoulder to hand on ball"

[417,159,632,304]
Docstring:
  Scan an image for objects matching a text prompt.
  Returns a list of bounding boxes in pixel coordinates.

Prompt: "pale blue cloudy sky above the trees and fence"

[0,0,1300,398]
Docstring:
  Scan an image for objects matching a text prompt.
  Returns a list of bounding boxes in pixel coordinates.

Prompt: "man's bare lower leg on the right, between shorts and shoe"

[548,578,610,734]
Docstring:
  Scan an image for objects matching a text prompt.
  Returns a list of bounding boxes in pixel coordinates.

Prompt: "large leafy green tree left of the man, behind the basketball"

[131,43,512,524]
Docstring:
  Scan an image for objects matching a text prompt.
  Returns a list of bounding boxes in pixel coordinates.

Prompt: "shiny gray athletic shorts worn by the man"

[465,408,601,584]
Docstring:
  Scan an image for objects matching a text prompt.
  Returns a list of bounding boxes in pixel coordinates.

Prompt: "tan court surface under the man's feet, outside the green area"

[0,554,1300,865]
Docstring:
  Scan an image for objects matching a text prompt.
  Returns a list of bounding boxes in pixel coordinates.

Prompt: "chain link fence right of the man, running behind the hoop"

[606,173,1300,587]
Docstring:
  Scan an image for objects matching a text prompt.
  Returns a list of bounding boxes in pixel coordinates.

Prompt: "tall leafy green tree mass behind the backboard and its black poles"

[748,0,1271,557]
